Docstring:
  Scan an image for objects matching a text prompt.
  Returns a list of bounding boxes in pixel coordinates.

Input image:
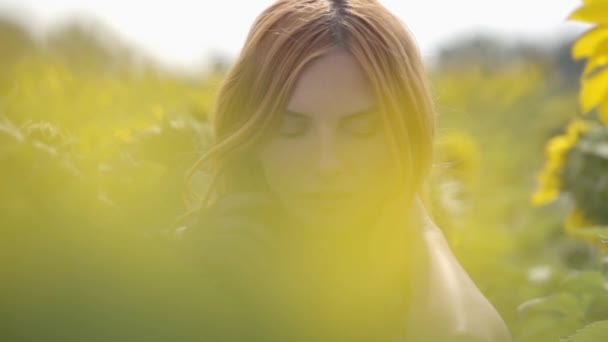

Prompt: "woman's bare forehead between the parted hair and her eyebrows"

[287,49,376,118]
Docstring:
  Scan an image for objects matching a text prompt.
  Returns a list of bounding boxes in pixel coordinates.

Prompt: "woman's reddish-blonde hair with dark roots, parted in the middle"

[189,0,435,214]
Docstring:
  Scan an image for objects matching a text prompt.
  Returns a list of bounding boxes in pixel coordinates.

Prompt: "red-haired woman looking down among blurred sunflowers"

[181,0,510,341]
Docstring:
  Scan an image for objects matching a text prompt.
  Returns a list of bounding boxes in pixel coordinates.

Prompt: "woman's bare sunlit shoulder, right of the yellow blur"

[410,220,512,342]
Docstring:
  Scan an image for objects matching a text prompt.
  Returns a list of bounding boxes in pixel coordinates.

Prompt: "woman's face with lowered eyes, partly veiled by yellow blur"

[258,49,397,234]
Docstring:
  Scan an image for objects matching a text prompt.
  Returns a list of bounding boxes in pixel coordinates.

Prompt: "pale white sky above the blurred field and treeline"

[0,0,587,68]
